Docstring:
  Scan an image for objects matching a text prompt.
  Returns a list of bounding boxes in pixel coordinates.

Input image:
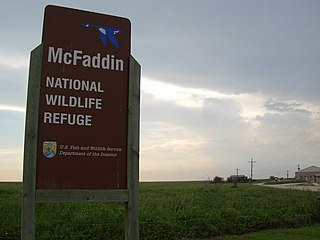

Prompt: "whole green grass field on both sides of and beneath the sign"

[0,182,319,240]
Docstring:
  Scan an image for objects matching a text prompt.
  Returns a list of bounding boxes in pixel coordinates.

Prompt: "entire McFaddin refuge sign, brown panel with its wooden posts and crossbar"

[21,6,140,240]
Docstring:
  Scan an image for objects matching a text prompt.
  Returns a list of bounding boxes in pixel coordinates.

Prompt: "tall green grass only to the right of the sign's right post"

[141,183,318,239]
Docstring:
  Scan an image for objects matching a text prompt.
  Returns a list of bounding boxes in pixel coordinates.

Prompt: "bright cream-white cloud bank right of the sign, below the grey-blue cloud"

[141,77,319,180]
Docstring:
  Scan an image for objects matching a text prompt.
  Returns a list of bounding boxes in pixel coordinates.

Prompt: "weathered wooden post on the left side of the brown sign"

[21,45,42,240]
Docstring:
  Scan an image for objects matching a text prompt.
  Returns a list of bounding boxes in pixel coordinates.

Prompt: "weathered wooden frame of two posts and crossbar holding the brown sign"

[21,6,141,240]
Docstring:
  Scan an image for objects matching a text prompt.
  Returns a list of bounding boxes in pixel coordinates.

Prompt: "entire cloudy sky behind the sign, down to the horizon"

[0,0,320,181]
